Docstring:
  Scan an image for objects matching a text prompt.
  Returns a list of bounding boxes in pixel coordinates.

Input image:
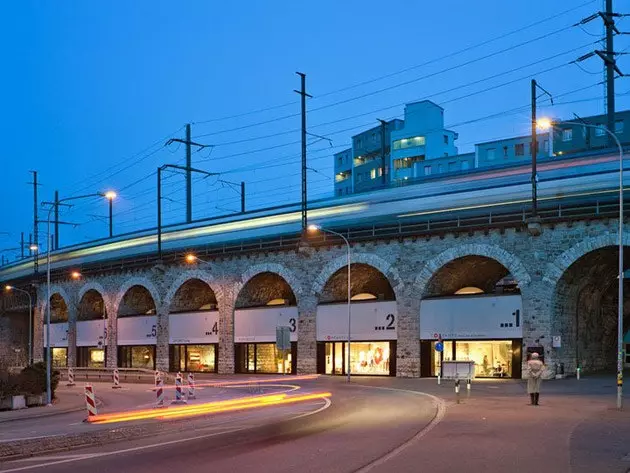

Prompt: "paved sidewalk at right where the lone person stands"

[353,376,630,473]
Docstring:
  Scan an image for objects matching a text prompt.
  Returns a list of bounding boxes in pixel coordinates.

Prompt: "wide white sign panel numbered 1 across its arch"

[420,294,523,340]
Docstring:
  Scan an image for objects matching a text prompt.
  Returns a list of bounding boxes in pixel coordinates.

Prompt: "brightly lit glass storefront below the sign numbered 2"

[318,341,396,376]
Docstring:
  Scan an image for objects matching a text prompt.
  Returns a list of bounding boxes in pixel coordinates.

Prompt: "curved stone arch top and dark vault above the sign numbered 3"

[235,263,302,308]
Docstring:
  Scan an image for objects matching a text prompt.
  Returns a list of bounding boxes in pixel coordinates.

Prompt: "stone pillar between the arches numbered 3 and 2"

[297,295,317,374]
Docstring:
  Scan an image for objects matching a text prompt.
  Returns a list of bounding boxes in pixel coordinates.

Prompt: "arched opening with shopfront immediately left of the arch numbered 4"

[117,285,157,370]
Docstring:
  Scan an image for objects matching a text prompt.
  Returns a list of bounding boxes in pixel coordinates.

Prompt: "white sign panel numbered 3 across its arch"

[234,306,298,343]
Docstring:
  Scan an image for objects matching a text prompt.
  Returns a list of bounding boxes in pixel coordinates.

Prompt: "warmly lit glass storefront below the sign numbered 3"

[235,342,297,374]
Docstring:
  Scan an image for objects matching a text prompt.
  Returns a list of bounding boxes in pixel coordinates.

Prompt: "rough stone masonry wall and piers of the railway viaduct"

[9,220,630,377]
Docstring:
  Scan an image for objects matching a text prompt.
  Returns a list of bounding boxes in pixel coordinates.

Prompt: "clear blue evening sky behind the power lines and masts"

[0,0,630,257]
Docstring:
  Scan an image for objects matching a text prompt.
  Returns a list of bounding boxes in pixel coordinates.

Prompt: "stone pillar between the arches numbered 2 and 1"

[396,289,420,378]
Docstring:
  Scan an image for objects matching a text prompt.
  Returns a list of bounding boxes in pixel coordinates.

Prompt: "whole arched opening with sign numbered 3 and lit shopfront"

[234,272,298,373]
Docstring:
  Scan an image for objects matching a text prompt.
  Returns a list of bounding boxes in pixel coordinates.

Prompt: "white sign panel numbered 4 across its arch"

[168,310,219,345]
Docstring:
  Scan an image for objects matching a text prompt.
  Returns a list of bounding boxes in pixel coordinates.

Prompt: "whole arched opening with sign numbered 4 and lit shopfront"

[168,279,219,372]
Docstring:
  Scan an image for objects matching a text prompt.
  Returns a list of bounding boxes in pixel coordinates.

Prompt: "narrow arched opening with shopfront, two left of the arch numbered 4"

[77,289,107,368]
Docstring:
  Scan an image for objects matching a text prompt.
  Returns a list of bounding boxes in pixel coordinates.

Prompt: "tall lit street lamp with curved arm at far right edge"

[536,118,623,410]
